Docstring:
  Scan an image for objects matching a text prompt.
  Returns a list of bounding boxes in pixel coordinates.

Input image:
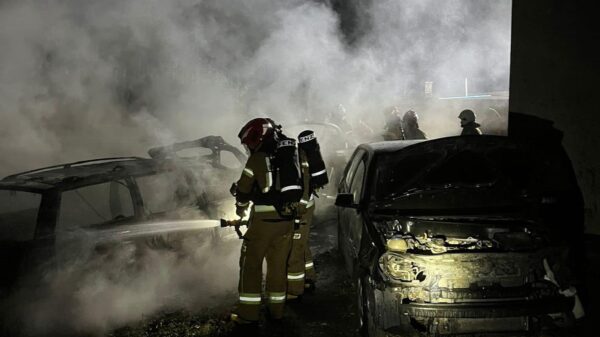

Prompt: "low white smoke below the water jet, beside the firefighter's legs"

[1,233,241,336]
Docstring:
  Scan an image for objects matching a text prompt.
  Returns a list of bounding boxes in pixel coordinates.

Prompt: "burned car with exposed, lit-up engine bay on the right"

[336,116,583,336]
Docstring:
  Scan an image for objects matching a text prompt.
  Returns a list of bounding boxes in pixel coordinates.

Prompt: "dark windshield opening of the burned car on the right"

[369,141,562,202]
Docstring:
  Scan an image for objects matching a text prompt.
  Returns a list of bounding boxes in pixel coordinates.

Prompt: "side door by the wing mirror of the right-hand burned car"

[338,150,366,274]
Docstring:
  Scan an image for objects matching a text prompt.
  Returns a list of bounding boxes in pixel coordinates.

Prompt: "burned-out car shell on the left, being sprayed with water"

[0,136,245,292]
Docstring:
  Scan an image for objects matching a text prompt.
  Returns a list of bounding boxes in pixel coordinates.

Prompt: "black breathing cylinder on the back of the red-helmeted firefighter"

[275,135,302,203]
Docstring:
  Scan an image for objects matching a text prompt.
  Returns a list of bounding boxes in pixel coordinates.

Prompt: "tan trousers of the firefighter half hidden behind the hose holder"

[287,206,316,296]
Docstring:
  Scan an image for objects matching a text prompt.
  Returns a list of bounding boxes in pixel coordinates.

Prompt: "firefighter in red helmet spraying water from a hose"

[231,118,301,326]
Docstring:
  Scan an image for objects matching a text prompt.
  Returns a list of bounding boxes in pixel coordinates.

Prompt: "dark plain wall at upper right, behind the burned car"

[510,0,600,234]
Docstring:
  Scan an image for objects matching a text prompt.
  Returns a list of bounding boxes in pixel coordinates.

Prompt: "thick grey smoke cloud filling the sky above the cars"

[0,0,511,174]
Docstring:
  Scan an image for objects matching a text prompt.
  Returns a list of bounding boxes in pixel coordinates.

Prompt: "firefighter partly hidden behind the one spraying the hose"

[287,130,328,299]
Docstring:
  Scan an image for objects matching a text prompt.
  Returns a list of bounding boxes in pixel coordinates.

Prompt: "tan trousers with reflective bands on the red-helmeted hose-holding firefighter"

[236,211,294,321]
